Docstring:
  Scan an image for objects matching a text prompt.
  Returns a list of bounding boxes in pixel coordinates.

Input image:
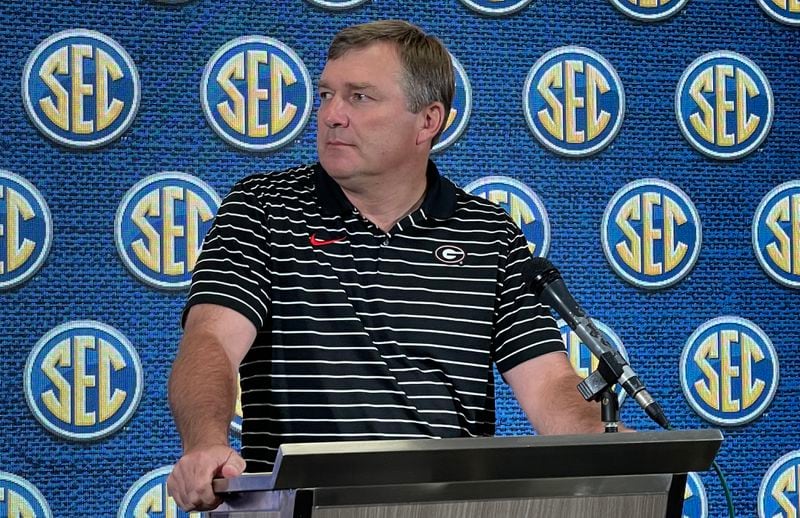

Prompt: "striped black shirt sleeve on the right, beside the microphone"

[492,219,566,374]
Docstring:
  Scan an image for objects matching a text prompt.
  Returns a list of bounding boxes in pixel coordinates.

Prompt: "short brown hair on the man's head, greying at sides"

[328,20,455,144]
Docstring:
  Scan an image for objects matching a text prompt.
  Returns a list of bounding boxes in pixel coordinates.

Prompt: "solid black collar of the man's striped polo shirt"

[313,160,456,219]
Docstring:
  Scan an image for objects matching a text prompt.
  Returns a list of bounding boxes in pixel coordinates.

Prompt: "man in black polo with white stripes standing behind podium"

[168,21,602,510]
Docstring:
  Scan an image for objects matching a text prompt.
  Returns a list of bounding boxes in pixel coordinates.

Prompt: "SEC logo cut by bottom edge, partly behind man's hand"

[117,466,203,518]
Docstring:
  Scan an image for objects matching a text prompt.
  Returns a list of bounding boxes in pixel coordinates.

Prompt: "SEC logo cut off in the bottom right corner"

[758,450,800,518]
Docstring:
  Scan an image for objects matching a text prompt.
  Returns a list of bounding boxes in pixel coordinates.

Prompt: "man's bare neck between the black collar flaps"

[340,163,427,232]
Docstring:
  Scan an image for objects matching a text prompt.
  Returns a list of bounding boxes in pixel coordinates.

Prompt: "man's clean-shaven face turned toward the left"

[317,43,430,184]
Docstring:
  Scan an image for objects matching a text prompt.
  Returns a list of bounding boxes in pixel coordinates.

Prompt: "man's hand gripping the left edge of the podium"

[167,445,245,511]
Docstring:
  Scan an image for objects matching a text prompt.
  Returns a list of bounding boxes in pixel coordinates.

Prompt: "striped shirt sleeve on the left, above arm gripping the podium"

[181,179,270,329]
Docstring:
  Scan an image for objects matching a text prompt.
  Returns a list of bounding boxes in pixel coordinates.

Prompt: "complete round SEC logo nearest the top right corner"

[675,51,774,160]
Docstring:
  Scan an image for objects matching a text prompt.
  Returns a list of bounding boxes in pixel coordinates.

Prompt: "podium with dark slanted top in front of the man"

[209,430,722,518]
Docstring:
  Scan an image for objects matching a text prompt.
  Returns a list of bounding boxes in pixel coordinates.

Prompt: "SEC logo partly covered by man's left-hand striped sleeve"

[114,172,221,290]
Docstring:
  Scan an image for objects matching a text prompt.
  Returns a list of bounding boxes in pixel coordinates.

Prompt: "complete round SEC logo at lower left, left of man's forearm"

[24,320,144,441]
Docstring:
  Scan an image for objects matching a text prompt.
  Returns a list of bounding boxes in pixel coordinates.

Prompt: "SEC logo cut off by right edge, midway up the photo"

[753,180,800,288]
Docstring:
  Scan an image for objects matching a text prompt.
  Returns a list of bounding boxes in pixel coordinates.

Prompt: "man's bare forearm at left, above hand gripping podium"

[169,335,237,451]
